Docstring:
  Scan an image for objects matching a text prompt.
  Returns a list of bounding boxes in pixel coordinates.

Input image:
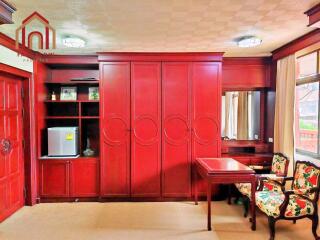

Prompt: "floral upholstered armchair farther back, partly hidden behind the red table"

[235,153,289,217]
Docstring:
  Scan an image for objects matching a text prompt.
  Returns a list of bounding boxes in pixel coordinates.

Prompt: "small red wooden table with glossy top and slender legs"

[194,158,256,231]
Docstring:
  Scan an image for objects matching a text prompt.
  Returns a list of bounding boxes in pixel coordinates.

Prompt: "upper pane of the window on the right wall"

[297,52,318,78]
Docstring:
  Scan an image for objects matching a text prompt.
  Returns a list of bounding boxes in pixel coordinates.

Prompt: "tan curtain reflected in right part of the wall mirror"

[237,91,249,140]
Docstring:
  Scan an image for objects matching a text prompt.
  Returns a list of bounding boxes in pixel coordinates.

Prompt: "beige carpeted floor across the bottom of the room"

[0,202,313,240]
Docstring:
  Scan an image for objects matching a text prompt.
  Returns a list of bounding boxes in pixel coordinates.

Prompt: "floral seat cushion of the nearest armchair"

[256,191,314,218]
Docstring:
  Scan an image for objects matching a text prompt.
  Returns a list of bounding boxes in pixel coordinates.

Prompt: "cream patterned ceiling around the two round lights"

[0,0,319,56]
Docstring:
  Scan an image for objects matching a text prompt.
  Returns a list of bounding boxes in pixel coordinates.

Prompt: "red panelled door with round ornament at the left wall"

[0,76,24,221]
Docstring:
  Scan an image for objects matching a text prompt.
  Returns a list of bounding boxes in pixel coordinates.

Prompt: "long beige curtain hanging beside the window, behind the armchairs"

[274,55,296,176]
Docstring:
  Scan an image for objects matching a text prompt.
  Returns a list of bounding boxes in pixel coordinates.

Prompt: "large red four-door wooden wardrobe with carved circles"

[99,53,222,199]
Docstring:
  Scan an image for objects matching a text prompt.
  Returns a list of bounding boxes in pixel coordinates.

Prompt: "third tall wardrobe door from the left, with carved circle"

[162,63,191,197]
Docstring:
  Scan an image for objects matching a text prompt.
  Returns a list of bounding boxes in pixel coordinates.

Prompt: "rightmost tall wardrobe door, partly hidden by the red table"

[192,62,221,195]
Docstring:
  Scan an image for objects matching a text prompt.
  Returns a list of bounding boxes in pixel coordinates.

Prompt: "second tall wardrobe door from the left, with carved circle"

[131,62,161,197]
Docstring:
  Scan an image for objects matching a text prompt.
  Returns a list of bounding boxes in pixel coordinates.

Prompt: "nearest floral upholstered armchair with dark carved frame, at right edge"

[256,161,320,240]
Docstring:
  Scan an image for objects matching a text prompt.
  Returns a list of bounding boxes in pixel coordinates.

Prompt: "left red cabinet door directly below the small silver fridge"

[40,160,70,197]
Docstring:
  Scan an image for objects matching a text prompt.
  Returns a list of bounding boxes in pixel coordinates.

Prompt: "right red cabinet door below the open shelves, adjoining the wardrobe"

[70,158,99,197]
